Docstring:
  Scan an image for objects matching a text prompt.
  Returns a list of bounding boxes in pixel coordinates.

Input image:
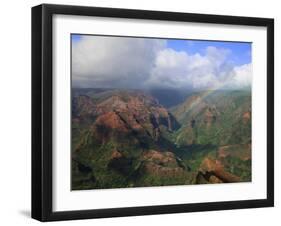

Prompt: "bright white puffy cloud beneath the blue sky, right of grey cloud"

[146,46,239,89]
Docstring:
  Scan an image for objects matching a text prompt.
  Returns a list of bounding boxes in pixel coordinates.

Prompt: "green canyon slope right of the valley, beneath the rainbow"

[171,91,251,183]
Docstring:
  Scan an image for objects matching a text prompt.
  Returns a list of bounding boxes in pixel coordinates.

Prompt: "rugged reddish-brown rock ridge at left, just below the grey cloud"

[73,92,178,143]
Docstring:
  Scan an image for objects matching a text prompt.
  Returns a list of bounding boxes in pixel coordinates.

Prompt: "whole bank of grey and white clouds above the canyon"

[72,36,252,89]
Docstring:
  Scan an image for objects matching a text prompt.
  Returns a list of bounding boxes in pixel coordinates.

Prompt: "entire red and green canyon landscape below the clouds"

[72,89,251,190]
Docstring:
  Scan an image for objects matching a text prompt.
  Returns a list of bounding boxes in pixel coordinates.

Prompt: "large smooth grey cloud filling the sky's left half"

[72,36,165,88]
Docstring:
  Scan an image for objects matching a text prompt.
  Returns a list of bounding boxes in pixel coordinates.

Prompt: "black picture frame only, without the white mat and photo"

[32,4,274,221]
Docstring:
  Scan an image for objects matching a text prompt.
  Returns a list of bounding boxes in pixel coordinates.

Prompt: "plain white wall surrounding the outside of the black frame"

[0,0,276,226]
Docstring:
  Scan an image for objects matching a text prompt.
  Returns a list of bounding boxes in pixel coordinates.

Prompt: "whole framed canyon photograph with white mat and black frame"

[32,4,274,221]
